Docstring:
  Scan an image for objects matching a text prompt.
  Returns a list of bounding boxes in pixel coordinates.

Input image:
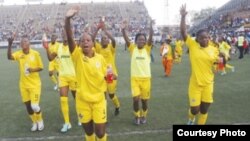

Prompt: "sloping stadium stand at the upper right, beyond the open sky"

[190,0,250,34]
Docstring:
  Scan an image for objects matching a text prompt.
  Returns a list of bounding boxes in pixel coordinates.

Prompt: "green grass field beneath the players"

[0,45,250,141]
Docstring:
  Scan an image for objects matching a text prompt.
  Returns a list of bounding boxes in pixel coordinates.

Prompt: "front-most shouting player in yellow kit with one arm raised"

[65,7,107,141]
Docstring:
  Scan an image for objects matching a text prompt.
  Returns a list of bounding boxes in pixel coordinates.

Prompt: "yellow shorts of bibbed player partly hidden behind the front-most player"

[58,74,76,90]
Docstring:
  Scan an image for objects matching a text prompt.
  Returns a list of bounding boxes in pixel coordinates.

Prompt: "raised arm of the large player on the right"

[180,4,187,41]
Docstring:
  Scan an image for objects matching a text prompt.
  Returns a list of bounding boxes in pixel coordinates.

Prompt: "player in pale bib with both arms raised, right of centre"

[121,20,153,125]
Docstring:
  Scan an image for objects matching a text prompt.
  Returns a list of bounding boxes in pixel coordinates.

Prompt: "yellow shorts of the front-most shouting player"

[76,99,107,123]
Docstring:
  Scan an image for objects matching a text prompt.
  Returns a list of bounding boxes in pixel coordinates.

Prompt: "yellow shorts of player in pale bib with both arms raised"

[131,78,151,99]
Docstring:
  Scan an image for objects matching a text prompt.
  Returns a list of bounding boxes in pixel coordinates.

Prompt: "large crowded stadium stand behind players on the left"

[0,1,150,41]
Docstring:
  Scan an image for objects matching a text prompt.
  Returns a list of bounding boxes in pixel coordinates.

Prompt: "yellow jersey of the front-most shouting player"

[71,48,107,102]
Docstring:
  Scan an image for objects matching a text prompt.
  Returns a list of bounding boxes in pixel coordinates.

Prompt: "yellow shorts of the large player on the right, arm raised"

[188,81,214,107]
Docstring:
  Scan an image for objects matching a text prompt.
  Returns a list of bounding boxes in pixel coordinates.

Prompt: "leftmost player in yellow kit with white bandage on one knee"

[7,37,44,131]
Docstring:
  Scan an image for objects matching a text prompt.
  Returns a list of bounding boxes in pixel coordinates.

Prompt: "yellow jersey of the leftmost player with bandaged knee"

[12,49,43,88]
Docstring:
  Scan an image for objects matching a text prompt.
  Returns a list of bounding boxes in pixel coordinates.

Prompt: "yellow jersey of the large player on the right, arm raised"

[186,35,219,86]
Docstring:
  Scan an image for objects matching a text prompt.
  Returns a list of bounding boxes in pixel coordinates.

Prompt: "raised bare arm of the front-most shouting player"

[64,6,80,53]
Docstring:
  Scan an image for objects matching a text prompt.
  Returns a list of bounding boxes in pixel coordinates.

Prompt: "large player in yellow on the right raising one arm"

[180,5,218,125]
